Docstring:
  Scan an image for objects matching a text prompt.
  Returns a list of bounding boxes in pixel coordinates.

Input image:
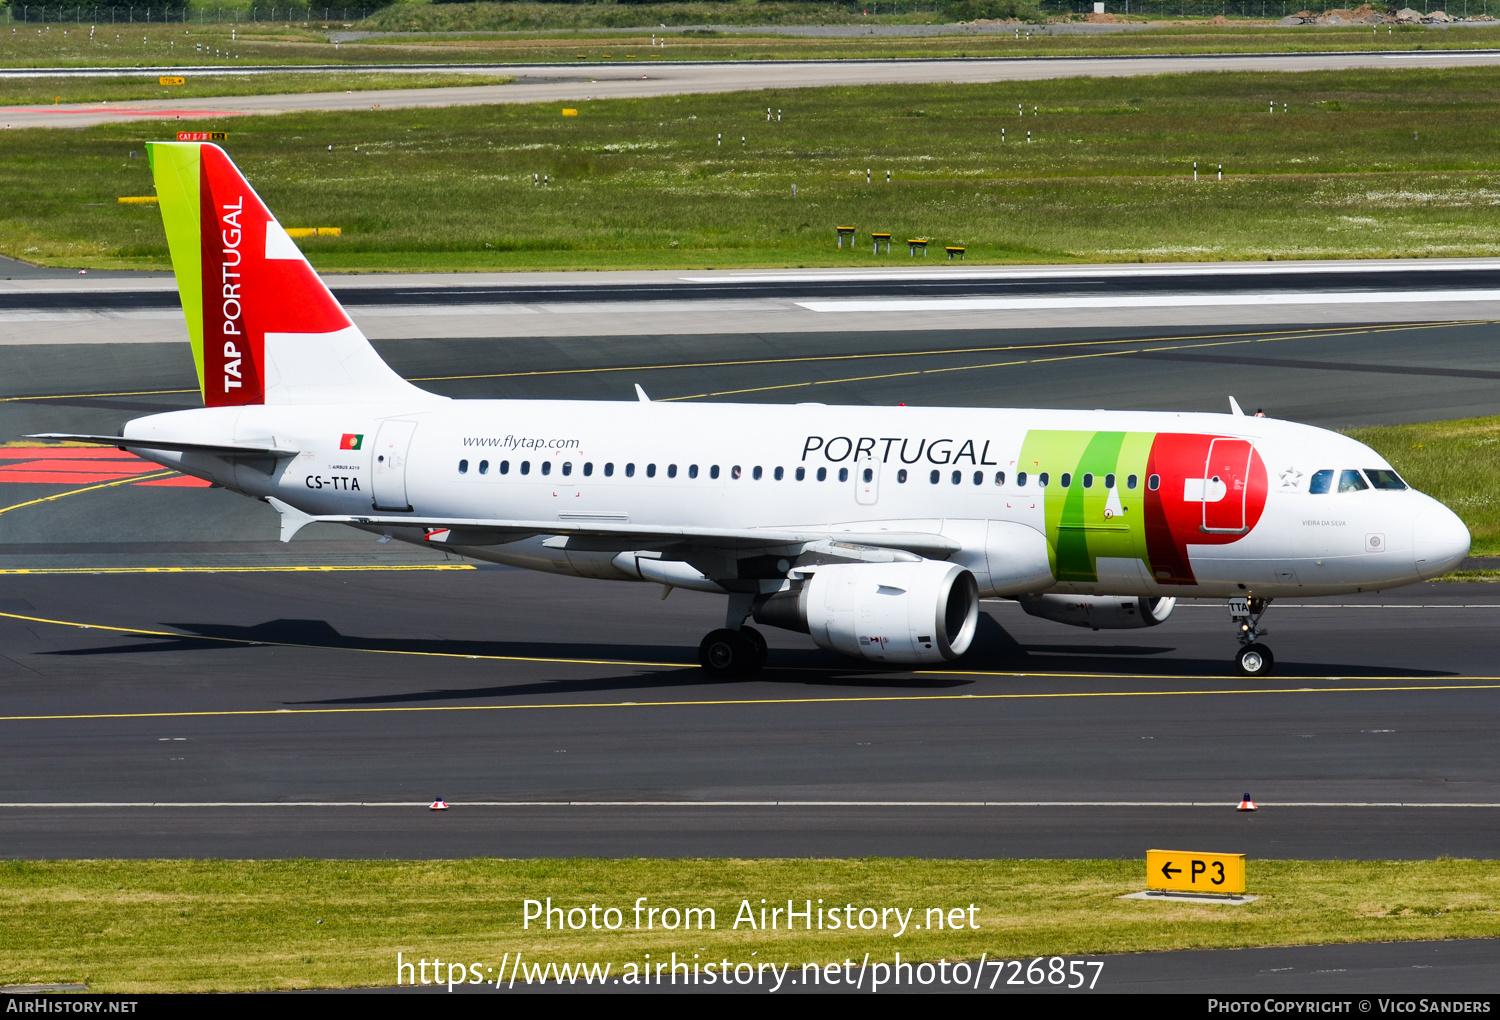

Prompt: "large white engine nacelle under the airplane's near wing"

[755,560,980,663]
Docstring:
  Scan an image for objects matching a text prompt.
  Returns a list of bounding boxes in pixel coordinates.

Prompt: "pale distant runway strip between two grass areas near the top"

[0,50,1500,129]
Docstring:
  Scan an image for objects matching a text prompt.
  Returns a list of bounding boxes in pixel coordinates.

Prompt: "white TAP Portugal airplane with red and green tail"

[36,143,1470,678]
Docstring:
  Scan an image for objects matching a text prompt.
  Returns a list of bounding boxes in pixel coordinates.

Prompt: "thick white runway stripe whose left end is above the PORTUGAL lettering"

[797,290,1500,312]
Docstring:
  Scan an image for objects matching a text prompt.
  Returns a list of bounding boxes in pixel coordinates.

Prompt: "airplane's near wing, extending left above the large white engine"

[312,515,960,560]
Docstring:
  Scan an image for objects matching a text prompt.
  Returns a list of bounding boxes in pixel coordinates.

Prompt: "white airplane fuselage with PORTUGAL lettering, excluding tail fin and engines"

[125,398,1469,597]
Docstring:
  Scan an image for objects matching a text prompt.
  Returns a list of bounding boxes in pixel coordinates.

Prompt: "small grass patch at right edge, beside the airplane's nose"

[1349,417,1500,558]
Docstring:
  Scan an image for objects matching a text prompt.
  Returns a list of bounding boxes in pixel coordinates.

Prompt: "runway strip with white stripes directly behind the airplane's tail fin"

[0,258,1500,347]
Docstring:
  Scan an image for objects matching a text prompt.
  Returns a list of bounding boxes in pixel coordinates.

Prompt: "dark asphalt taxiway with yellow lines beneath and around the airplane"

[0,313,1500,858]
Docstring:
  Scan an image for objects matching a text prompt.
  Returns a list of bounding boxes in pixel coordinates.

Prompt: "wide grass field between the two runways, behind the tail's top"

[0,69,1500,270]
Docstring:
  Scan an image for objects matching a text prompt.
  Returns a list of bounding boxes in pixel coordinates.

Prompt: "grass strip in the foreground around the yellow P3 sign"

[0,858,1500,992]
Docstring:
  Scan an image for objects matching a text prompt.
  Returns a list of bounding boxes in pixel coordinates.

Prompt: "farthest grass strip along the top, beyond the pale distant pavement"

[0,18,1500,68]
